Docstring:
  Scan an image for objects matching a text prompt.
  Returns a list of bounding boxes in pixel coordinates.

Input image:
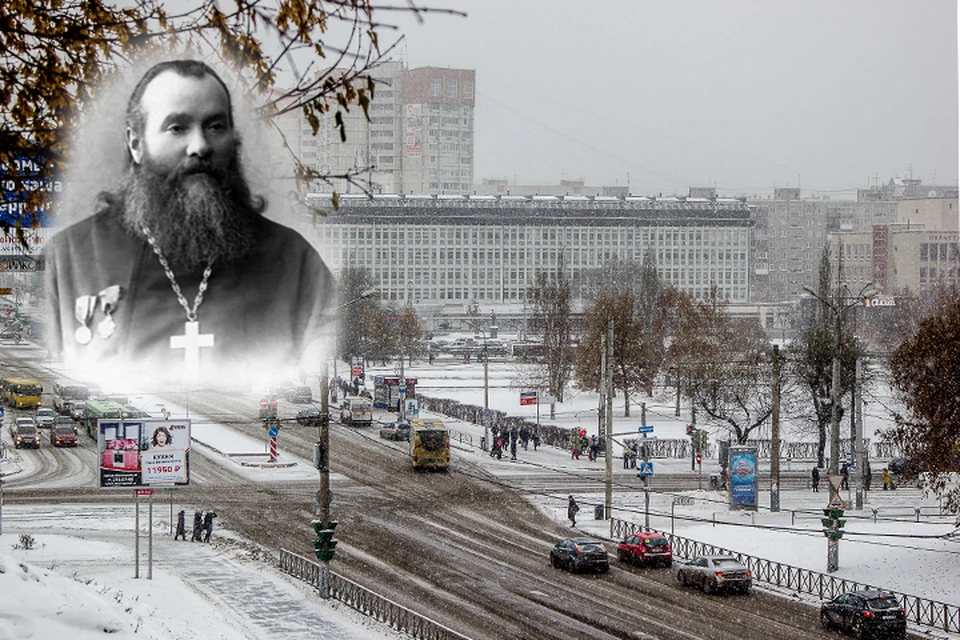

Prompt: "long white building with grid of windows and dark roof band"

[311,194,753,311]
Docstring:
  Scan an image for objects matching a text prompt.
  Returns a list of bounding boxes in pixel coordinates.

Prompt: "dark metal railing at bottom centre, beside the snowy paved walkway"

[278,549,470,640]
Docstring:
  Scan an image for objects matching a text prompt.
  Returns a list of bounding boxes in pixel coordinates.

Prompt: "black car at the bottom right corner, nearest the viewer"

[820,589,907,638]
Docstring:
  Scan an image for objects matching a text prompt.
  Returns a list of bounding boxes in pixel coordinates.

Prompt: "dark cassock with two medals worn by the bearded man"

[46,208,335,378]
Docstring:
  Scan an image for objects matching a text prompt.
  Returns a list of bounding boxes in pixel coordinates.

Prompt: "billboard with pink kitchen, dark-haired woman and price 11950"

[97,418,190,489]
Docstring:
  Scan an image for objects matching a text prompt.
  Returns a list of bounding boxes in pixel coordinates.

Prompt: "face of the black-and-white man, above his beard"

[127,71,236,176]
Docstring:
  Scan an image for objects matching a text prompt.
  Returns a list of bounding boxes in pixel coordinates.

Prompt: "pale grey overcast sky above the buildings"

[381,0,958,197]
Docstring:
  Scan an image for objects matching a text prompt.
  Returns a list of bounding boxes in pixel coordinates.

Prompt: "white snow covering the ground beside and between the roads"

[0,352,960,640]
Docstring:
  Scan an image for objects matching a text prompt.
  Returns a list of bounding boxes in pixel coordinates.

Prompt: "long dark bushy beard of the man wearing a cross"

[123,155,264,272]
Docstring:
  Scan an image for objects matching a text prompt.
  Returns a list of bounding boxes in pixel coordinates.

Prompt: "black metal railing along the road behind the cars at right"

[610,518,960,632]
